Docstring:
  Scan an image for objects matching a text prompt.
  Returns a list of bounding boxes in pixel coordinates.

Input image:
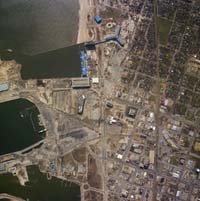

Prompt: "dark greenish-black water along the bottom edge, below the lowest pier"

[0,166,80,201]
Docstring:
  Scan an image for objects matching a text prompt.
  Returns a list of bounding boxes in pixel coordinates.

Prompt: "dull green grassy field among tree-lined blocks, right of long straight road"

[158,17,171,45]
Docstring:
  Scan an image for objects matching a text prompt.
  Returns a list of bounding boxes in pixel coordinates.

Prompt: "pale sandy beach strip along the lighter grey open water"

[77,0,92,43]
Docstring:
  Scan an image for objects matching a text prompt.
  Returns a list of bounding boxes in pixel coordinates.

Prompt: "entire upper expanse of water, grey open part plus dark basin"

[0,0,81,79]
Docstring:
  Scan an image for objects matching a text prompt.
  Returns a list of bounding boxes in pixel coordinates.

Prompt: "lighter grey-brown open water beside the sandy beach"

[0,0,79,55]
